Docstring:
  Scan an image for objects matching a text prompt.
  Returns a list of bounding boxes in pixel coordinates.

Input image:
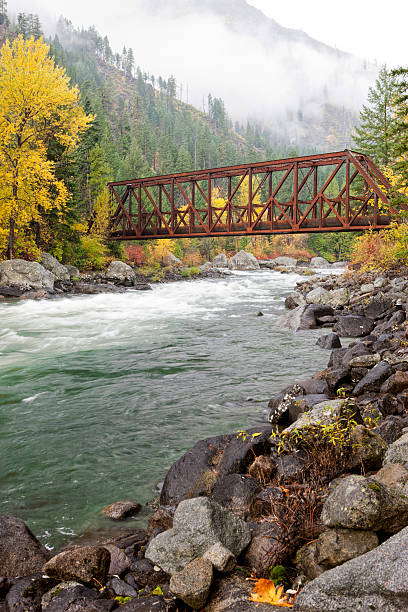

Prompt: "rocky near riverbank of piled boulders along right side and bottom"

[0,263,408,612]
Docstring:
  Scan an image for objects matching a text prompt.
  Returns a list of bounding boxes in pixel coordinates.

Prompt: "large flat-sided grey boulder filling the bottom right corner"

[293,528,408,612]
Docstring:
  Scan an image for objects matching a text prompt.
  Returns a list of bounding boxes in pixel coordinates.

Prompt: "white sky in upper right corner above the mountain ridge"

[248,0,408,67]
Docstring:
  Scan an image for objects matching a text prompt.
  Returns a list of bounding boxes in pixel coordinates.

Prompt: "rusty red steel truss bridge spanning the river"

[100,150,391,240]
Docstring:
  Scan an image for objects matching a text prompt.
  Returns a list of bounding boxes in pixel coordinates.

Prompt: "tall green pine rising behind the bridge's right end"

[353,66,396,165]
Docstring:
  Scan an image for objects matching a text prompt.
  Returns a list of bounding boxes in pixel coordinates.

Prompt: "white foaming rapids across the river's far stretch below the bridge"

[0,271,298,366]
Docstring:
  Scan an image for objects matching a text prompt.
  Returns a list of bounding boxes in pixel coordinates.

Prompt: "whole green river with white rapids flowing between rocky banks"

[0,270,327,547]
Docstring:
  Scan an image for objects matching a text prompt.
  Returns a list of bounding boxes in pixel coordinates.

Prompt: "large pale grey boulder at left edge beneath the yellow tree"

[0,259,55,291]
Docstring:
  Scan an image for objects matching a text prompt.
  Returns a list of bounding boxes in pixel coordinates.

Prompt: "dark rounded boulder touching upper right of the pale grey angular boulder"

[211,474,261,519]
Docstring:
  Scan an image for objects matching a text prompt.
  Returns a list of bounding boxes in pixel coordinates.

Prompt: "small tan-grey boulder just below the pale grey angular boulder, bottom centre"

[170,558,213,610]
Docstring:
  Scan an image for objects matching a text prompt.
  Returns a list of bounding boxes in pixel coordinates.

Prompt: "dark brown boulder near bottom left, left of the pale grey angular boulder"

[43,546,110,584]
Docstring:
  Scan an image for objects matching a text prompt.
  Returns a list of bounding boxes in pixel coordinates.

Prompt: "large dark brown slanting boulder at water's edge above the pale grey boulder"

[160,427,272,506]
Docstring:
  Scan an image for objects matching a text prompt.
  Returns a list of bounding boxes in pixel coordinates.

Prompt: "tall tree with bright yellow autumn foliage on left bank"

[0,36,93,258]
